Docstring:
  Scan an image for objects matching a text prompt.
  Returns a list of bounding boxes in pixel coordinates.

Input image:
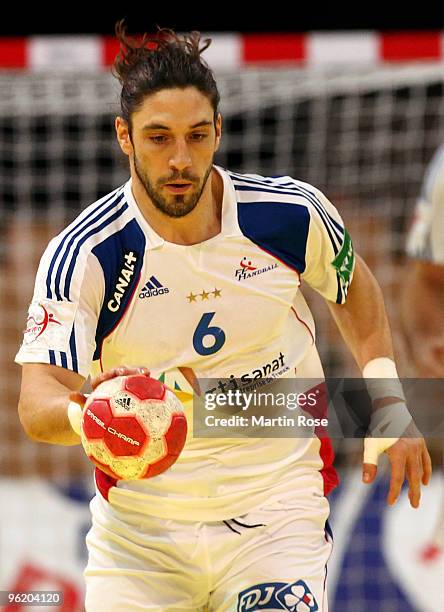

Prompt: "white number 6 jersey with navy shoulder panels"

[16,168,354,520]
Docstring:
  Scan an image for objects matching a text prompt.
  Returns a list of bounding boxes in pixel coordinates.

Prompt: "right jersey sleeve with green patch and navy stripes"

[301,190,355,304]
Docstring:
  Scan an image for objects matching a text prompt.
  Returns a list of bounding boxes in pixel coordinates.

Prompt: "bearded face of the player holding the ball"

[116,87,221,217]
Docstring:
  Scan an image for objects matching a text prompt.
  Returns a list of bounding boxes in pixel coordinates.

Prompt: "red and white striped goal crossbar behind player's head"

[0,31,444,71]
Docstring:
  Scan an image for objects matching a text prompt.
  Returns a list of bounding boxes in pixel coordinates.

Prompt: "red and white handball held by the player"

[80,374,187,480]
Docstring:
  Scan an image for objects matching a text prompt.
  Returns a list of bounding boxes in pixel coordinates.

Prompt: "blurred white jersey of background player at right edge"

[407,146,444,264]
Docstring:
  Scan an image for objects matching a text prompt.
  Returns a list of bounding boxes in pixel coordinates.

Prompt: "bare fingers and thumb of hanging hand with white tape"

[362,422,432,508]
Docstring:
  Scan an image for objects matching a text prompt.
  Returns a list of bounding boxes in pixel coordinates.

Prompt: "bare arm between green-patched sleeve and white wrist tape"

[328,256,393,371]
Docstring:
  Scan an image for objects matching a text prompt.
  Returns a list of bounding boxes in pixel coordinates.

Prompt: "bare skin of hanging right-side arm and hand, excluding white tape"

[328,256,431,507]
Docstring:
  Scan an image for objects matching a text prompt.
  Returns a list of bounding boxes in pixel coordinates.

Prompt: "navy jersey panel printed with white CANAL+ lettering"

[92,219,146,360]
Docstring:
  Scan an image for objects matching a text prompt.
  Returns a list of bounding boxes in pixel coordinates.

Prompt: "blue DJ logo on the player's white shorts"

[237,580,319,612]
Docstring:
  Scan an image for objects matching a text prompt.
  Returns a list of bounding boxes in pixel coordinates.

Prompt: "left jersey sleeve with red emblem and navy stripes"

[15,238,104,378]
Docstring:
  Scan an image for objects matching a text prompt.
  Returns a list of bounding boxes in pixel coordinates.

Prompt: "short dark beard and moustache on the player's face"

[134,155,213,218]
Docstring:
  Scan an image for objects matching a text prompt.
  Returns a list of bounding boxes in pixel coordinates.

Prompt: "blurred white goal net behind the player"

[0,64,444,476]
